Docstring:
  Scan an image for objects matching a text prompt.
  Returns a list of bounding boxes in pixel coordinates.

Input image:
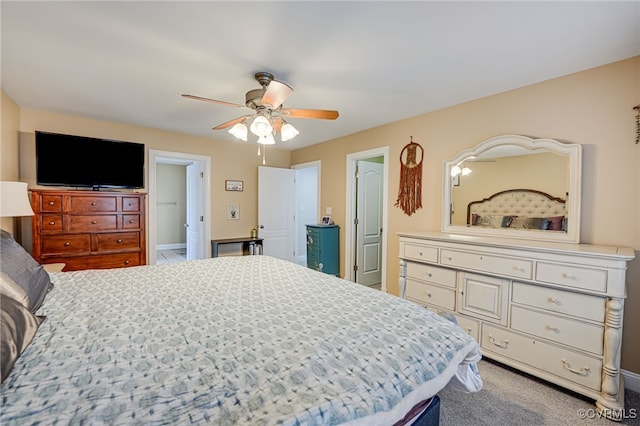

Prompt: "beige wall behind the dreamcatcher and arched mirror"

[291,57,640,373]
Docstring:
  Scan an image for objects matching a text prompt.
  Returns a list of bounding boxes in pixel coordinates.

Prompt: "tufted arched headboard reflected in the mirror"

[467,189,566,232]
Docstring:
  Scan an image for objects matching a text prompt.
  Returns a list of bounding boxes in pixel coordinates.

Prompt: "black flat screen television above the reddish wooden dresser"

[36,131,144,190]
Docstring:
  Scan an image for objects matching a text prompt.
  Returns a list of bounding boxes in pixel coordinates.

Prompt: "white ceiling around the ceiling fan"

[1,0,640,149]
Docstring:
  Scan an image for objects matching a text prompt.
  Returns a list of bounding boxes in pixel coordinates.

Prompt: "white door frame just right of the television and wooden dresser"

[147,149,211,265]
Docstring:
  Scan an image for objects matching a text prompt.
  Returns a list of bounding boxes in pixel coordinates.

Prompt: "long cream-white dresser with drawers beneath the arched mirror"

[399,231,634,420]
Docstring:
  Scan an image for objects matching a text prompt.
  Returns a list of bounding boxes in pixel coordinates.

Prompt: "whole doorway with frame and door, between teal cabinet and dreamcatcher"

[345,147,389,292]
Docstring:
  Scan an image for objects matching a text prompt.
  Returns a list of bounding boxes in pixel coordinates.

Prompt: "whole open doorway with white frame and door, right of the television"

[147,149,211,264]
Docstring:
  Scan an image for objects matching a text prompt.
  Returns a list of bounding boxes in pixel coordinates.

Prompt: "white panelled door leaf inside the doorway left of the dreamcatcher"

[356,160,383,286]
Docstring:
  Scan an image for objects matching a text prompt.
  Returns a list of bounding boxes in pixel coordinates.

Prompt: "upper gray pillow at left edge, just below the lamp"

[0,230,53,313]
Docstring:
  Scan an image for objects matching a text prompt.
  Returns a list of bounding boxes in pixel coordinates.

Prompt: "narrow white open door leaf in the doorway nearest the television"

[184,162,205,260]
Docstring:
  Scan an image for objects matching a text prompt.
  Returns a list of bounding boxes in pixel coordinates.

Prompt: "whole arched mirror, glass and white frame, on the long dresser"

[442,135,582,243]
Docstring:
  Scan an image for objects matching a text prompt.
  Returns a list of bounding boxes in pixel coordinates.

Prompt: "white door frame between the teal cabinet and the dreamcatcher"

[344,146,389,292]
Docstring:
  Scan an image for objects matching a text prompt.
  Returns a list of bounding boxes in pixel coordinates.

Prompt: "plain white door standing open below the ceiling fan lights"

[258,166,296,262]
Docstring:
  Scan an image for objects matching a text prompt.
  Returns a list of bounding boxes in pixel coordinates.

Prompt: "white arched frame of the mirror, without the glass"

[442,135,582,243]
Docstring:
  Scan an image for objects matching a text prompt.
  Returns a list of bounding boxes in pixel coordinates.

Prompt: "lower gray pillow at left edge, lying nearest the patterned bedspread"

[0,296,43,383]
